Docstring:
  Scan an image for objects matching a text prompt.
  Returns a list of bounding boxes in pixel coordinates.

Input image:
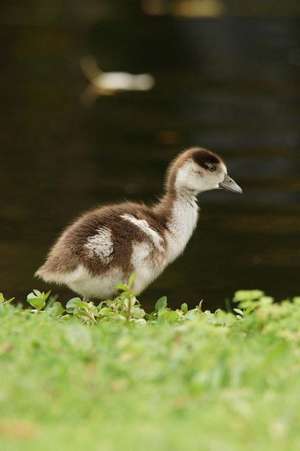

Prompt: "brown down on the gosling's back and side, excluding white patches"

[38,202,165,275]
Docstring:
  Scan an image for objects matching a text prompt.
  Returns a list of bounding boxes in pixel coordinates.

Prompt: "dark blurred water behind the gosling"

[0,0,300,308]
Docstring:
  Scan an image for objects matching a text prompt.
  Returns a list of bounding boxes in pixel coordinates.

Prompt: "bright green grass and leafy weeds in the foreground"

[0,287,300,451]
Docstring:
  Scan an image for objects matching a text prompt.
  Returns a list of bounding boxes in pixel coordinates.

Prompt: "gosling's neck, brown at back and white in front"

[155,191,199,262]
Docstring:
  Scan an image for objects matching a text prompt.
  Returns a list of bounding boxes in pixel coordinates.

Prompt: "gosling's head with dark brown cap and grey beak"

[166,148,242,195]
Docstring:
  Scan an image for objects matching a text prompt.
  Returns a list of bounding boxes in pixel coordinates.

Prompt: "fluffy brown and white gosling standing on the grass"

[36,148,242,299]
